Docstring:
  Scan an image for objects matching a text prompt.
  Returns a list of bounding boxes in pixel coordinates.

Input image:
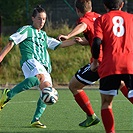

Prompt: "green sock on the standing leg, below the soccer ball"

[31,98,47,123]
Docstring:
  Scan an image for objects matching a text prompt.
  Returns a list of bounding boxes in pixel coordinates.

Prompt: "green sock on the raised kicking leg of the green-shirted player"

[7,77,40,99]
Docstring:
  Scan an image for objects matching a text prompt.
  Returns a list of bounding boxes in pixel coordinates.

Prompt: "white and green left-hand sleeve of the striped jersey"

[9,26,28,45]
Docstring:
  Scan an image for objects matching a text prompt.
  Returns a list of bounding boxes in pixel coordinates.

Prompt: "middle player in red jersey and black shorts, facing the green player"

[58,0,102,127]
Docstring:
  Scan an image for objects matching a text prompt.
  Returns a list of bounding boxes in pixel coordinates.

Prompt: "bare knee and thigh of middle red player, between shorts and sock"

[69,76,85,95]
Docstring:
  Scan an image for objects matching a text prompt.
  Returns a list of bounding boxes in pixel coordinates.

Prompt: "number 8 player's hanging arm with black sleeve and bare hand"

[91,37,102,71]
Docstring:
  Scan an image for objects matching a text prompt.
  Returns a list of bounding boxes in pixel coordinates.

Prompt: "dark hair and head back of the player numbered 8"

[103,0,123,10]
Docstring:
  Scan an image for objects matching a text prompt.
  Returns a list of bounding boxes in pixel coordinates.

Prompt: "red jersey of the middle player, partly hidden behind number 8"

[78,12,102,62]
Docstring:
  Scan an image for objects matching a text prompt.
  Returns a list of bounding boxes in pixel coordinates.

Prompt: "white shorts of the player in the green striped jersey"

[22,59,52,86]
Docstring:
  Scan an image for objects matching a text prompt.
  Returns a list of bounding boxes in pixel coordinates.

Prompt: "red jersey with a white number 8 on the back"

[94,10,133,78]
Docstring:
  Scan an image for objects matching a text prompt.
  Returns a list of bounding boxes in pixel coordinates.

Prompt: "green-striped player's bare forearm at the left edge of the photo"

[0,41,14,62]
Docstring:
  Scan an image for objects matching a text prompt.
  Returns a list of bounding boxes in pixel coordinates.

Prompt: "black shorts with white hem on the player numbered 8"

[99,74,133,95]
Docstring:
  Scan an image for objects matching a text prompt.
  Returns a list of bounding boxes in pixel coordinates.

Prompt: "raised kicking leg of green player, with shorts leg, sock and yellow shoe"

[0,60,41,110]
